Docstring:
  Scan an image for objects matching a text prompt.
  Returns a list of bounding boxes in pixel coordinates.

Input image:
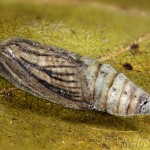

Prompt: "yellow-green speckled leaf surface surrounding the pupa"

[0,1,150,150]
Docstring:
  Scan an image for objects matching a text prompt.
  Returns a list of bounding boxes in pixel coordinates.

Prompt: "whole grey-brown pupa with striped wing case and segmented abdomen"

[0,38,150,116]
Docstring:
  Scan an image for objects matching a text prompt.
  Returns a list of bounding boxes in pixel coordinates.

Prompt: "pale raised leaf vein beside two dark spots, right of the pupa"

[97,33,150,62]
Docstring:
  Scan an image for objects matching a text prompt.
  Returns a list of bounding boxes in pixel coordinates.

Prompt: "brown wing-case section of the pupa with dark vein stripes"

[0,39,90,109]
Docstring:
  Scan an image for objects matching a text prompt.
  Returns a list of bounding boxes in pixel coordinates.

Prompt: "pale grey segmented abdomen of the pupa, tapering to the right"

[94,64,150,116]
